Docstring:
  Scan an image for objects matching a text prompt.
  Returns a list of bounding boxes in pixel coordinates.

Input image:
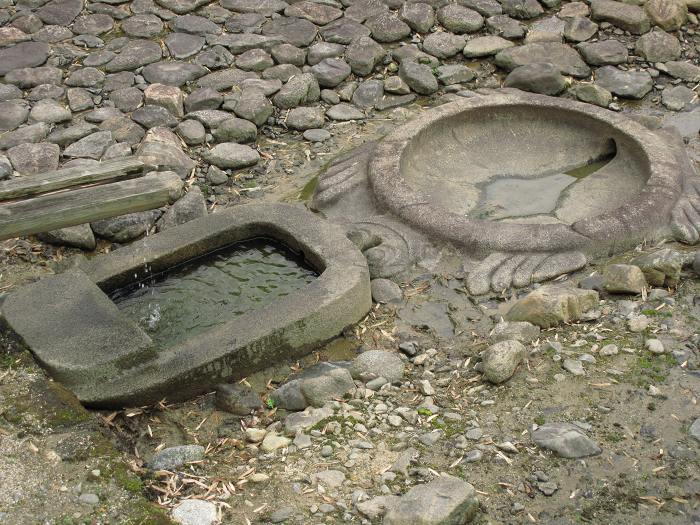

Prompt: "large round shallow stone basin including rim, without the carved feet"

[369,93,681,253]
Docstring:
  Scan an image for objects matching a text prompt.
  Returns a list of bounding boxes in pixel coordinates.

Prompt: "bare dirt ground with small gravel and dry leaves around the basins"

[0,96,700,525]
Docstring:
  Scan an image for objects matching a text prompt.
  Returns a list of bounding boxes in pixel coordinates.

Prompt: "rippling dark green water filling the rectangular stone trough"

[110,239,318,346]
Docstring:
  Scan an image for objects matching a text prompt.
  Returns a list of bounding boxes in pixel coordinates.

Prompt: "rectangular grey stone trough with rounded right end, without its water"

[2,204,371,407]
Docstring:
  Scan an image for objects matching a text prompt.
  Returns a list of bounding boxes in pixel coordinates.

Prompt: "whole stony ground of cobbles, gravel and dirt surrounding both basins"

[0,0,700,525]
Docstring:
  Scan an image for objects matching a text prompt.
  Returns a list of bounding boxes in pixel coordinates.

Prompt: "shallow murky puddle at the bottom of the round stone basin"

[470,156,613,219]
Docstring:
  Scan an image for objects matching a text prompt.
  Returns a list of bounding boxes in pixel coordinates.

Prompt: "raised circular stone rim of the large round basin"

[369,93,685,255]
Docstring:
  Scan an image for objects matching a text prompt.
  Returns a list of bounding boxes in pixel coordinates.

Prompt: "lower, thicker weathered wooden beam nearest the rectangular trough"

[0,172,183,240]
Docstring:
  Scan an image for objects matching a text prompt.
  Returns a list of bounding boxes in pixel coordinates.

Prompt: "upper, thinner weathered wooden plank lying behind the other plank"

[0,157,153,201]
